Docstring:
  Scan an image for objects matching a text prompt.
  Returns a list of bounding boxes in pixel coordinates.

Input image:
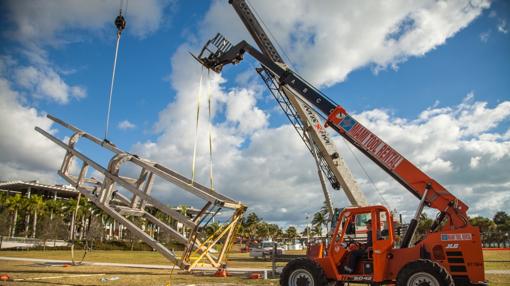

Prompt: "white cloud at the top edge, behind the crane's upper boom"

[201,0,489,85]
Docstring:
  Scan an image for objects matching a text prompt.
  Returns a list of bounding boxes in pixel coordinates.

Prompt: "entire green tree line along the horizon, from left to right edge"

[0,193,510,247]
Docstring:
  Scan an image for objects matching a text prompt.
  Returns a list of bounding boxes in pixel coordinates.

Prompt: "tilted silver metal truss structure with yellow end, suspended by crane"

[35,115,246,270]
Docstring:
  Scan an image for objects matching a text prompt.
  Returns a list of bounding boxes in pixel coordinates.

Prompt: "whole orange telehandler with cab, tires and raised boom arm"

[195,0,487,286]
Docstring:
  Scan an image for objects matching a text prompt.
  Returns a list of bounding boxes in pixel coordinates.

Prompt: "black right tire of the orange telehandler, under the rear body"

[397,259,455,286]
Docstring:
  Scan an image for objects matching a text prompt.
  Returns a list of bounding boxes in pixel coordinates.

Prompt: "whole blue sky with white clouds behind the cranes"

[0,0,510,225]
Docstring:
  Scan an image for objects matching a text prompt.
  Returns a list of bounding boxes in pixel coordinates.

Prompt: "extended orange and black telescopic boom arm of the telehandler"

[198,37,468,228]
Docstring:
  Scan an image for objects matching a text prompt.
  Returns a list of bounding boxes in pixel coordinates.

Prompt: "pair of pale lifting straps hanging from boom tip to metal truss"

[191,67,214,190]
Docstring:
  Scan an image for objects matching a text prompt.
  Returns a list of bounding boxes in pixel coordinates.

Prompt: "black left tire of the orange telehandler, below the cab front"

[280,258,328,286]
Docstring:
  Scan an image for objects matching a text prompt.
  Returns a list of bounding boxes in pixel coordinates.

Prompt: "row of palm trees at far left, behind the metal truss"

[0,193,191,246]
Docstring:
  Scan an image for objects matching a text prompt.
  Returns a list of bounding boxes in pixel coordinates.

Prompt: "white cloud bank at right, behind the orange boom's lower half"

[334,96,510,219]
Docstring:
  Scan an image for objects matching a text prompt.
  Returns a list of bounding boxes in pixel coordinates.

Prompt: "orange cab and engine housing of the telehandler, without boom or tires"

[309,206,485,285]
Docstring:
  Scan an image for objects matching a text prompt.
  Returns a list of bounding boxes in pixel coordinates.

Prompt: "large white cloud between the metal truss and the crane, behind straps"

[132,46,330,221]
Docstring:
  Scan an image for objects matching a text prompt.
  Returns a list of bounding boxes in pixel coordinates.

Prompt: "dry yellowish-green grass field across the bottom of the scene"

[0,247,510,286]
